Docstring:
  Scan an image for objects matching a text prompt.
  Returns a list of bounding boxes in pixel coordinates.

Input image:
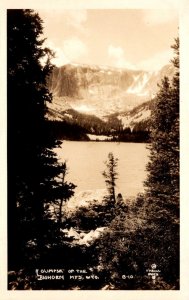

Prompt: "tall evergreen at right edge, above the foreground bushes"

[145,39,179,219]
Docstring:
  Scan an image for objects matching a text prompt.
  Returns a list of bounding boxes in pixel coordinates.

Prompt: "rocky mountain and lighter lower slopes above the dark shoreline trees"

[48,64,174,141]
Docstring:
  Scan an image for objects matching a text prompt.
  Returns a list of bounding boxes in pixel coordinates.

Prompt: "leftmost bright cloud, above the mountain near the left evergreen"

[63,37,88,61]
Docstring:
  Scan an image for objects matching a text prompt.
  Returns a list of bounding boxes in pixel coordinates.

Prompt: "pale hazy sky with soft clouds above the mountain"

[38,9,178,70]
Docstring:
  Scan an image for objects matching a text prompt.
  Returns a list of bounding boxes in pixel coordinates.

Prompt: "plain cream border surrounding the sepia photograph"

[0,0,189,300]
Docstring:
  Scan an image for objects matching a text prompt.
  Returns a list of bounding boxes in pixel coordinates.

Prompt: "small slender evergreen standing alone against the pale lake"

[102,152,118,203]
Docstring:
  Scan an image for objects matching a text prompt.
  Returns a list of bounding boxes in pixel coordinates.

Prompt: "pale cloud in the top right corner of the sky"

[143,9,178,25]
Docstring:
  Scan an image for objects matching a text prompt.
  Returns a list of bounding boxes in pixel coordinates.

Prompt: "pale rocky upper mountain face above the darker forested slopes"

[48,64,173,117]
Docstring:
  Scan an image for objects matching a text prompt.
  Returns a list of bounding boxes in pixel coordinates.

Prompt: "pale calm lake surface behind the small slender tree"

[56,141,149,196]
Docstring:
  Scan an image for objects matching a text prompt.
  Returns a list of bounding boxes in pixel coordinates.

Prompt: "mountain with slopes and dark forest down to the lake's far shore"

[47,64,174,142]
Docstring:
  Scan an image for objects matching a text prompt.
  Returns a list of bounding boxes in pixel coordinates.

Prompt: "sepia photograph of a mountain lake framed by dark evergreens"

[0,0,189,299]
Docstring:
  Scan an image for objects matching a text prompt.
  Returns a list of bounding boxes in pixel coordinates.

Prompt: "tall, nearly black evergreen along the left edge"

[7,9,75,268]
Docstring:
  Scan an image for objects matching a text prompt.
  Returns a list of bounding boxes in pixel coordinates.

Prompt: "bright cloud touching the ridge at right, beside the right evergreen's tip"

[137,49,173,71]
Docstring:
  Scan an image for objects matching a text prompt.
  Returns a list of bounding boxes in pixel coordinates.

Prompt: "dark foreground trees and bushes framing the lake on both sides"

[7,10,179,290]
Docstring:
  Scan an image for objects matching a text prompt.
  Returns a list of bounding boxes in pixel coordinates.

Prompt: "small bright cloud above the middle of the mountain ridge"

[108,45,136,70]
